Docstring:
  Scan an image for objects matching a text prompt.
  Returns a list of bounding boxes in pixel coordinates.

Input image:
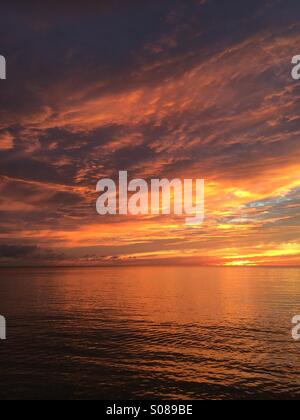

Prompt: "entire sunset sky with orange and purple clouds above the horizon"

[0,0,300,266]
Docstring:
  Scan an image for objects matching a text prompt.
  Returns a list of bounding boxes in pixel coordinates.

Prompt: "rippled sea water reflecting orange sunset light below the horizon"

[0,268,300,399]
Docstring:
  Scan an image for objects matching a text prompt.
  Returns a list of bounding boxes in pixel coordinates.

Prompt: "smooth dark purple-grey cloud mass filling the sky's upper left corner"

[0,0,300,122]
